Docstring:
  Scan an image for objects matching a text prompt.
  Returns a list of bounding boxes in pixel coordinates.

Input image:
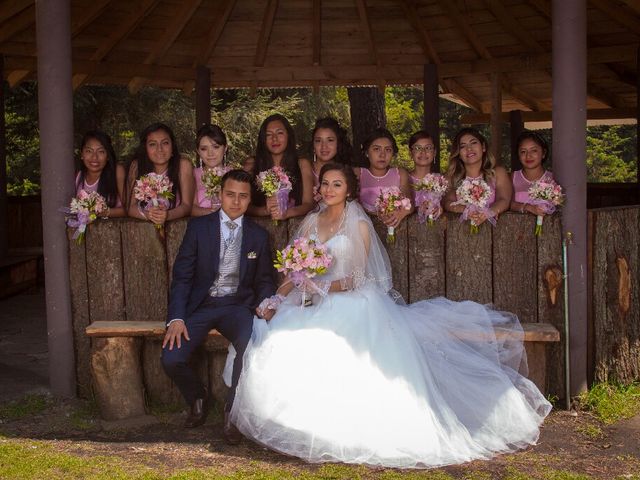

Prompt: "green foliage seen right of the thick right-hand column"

[587,125,637,182]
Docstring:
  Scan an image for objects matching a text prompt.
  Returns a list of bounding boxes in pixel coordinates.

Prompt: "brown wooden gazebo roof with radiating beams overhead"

[0,0,640,112]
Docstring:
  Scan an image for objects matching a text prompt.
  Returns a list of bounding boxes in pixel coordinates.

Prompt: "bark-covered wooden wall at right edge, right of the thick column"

[592,207,640,383]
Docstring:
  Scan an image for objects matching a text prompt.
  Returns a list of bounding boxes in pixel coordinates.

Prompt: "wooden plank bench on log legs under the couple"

[86,321,560,420]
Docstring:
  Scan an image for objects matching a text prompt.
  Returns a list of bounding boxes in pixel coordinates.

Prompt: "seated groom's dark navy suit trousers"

[162,296,253,411]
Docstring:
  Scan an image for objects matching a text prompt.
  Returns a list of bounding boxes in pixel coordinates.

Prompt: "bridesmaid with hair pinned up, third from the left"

[191,124,227,217]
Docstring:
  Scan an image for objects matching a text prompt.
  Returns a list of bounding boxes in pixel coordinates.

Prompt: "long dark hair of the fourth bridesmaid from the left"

[252,113,302,206]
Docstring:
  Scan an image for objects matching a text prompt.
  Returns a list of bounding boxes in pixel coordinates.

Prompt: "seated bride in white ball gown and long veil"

[231,164,551,468]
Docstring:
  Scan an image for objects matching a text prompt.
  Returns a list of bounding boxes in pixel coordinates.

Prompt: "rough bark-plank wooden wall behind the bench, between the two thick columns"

[69,213,564,401]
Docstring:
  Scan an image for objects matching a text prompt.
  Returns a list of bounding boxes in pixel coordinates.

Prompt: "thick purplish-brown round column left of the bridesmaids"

[36,0,76,397]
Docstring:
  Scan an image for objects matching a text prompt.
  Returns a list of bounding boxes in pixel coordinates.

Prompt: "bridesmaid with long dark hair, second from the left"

[127,123,194,225]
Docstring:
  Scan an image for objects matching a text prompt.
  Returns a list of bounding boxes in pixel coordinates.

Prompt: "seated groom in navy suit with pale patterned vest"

[162,170,276,444]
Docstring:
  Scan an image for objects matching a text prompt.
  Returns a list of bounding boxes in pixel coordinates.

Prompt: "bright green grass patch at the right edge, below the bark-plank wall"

[578,383,640,424]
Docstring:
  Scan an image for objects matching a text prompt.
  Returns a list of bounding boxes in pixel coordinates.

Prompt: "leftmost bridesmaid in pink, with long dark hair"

[76,130,125,217]
